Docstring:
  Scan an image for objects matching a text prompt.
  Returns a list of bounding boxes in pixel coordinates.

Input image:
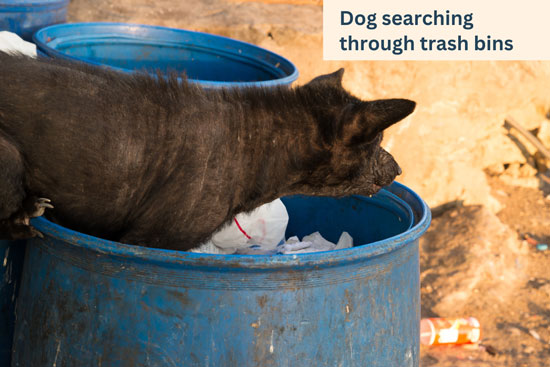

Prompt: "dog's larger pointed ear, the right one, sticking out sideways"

[339,99,416,146]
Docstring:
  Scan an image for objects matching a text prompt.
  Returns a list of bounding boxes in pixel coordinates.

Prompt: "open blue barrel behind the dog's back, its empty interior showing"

[33,23,298,87]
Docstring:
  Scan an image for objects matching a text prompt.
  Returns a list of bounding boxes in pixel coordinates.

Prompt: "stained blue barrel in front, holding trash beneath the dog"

[12,183,430,367]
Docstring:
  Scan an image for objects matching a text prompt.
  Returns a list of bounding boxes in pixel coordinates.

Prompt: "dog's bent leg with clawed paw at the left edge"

[0,135,53,240]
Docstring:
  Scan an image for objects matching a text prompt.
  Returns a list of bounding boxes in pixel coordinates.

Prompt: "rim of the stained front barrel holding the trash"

[31,182,431,269]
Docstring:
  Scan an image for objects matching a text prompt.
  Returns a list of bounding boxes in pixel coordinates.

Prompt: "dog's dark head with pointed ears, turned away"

[295,69,416,196]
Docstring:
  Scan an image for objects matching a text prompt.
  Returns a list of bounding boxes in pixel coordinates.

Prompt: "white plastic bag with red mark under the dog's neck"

[191,199,288,254]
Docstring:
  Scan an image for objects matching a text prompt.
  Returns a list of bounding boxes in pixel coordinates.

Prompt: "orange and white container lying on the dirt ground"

[420,317,481,345]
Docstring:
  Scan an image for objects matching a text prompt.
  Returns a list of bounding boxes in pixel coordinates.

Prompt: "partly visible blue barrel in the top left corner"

[0,0,69,41]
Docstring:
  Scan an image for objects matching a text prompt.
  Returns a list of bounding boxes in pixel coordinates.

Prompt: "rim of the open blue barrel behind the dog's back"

[33,22,299,87]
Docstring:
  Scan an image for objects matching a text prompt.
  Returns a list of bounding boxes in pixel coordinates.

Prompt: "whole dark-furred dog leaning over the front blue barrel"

[0,53,415,250]
